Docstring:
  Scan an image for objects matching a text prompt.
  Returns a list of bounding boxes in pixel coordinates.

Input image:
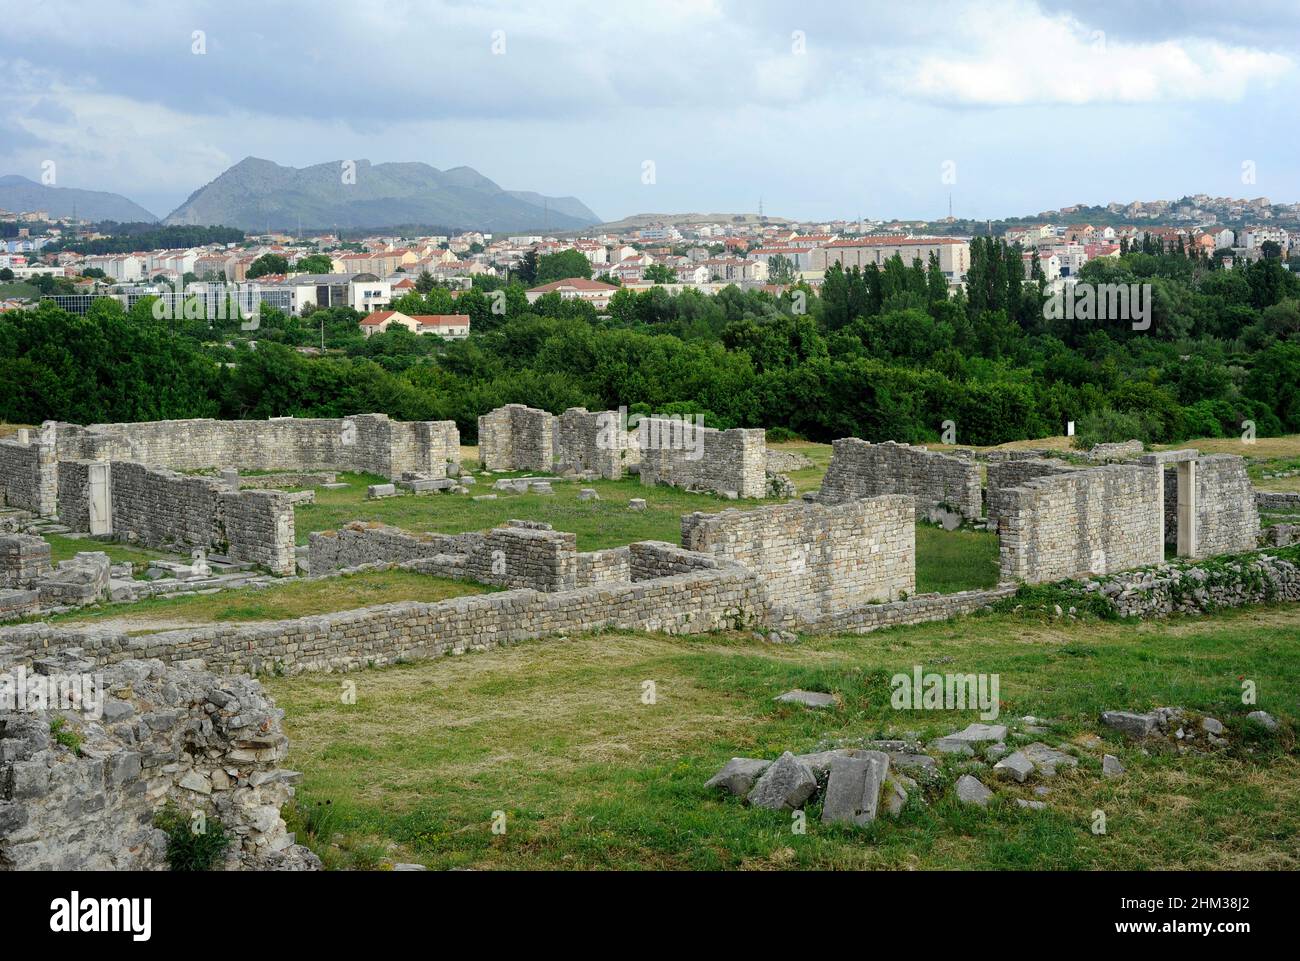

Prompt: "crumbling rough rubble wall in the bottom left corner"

[0,649,320,871]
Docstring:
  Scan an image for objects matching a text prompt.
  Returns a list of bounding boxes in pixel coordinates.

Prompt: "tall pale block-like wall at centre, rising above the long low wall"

[681,494,917,616]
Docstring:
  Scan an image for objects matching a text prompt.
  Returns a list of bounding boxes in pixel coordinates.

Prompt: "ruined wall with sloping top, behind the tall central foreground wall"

[822,437,982,520]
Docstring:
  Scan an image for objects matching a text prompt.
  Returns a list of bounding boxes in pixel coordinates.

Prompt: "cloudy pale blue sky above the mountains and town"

[0,0,1300,220]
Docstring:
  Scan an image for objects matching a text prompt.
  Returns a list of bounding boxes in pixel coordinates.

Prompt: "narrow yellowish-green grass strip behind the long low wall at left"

[52,571,498,633]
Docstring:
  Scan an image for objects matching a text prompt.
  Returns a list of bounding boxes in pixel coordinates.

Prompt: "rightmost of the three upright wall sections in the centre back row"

[637,417,767,498]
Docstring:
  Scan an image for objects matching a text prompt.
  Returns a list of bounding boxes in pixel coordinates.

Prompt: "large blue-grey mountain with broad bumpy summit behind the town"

[163,157,601,233]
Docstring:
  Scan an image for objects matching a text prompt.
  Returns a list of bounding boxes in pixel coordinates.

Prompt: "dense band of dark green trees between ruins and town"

[0,239,1300,443]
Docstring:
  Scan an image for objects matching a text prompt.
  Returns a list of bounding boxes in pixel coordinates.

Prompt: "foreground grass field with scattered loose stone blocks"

[265,607,1300,870]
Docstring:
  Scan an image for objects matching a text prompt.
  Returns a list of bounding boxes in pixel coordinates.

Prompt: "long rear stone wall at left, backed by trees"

[53,414,460,479]
